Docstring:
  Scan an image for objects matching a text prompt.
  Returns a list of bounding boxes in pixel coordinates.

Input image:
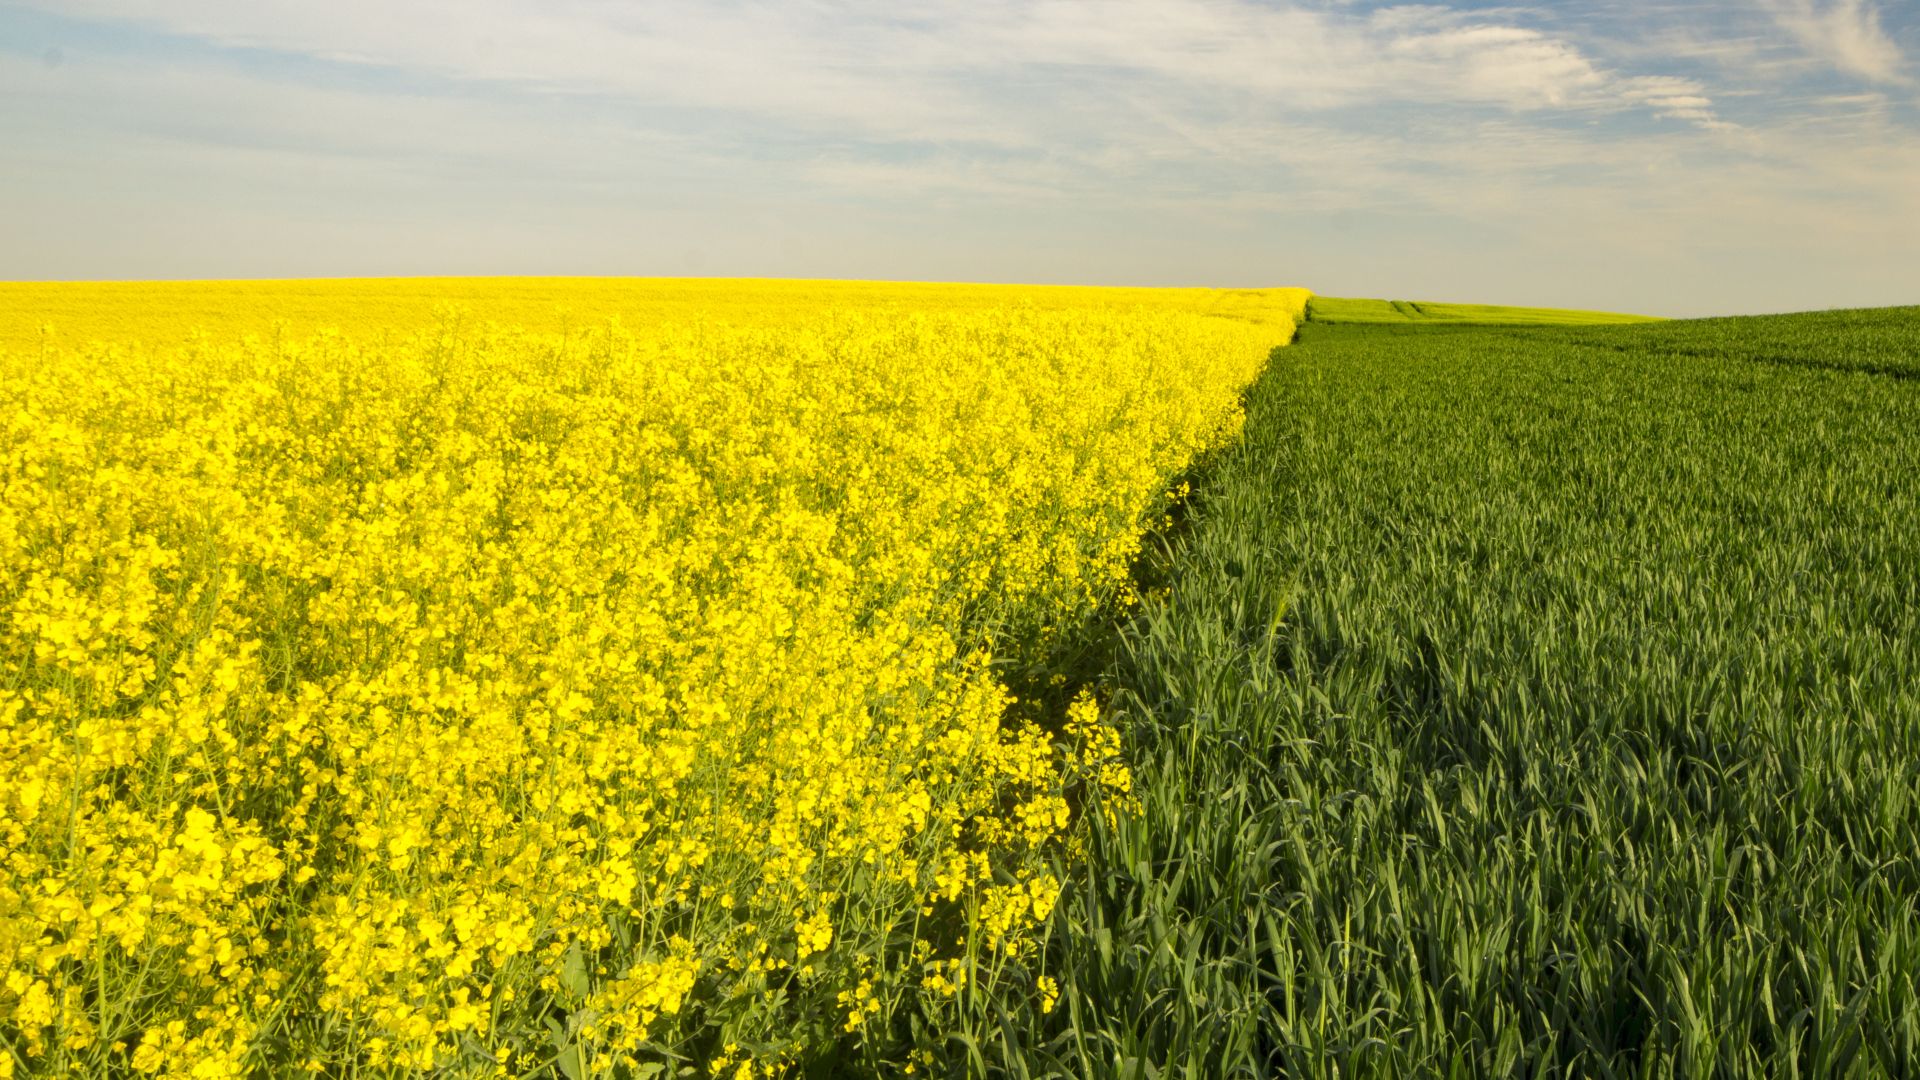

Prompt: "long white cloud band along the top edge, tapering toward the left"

[15,0,1720,126]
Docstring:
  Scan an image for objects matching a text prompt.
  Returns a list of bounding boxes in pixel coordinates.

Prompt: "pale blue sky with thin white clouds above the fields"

[0,0,1920,315]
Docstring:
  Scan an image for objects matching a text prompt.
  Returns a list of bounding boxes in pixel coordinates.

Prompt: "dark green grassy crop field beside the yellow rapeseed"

[968,300,1920,1078]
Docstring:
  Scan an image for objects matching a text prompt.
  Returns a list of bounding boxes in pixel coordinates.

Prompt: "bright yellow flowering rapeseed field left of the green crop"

[0,279,1306,1076]
